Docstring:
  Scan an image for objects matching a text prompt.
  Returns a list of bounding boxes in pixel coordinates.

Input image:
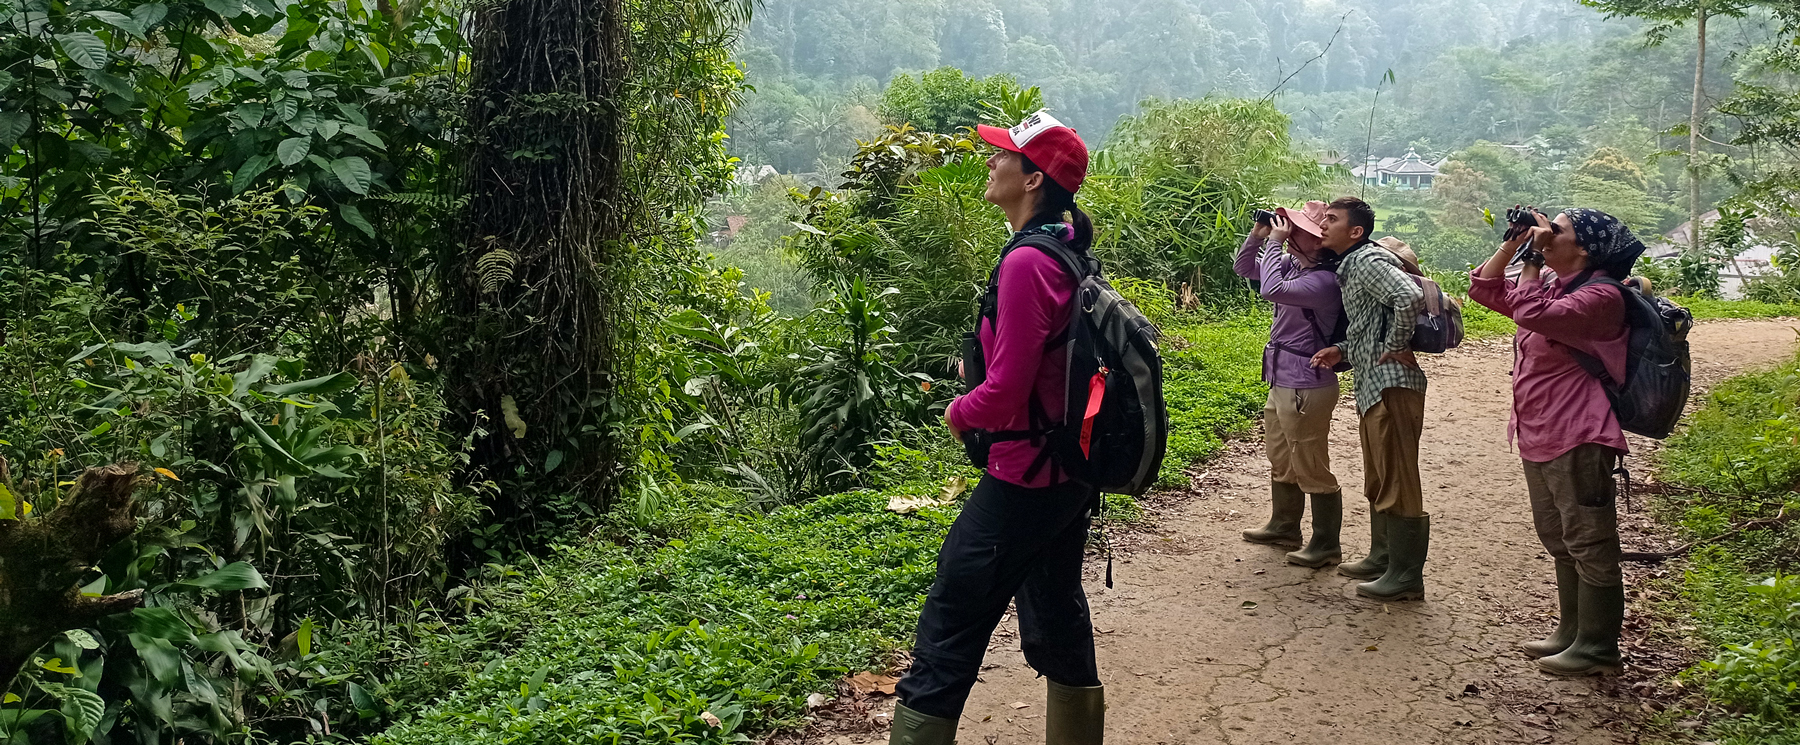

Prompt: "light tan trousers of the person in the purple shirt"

[1262,385,1337,495]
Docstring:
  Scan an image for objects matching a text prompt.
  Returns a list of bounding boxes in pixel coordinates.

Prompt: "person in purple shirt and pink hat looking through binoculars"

[1233,202,1345,567]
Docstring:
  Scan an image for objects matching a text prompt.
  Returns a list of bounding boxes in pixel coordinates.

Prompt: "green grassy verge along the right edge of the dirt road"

[1656,352,1800,743]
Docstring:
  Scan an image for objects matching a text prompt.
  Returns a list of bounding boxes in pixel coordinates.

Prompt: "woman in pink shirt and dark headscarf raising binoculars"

[1469,209,1643,675]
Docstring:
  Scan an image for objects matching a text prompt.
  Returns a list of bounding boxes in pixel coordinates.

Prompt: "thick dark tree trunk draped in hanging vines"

[443,0,634,529]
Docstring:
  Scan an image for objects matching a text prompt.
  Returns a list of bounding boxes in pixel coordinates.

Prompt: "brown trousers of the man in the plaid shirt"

[1357,389,1426,516]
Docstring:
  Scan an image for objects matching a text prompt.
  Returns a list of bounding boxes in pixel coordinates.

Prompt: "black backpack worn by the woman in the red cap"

[963,232,1168,495]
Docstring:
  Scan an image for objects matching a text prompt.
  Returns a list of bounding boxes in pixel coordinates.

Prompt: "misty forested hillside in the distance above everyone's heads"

[731,0,1773,171]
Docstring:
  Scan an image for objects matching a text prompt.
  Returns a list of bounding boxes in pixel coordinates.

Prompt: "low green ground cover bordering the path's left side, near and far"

[373,313,1269,745]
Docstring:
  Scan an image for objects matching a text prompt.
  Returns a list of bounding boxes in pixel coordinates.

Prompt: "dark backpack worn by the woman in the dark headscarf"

[1564,274,1694,439]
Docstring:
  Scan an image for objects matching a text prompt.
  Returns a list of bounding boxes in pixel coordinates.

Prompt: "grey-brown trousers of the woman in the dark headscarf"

[1525,443,1625,587]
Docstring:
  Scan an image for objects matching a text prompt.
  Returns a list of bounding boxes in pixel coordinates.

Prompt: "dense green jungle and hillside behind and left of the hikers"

[0,0,1800,743]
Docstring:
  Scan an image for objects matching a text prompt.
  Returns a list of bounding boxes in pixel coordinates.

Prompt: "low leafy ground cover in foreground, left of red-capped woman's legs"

[376,491,954,745]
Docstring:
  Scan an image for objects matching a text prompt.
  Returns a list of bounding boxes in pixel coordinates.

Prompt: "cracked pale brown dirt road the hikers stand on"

[950,320,1796,745]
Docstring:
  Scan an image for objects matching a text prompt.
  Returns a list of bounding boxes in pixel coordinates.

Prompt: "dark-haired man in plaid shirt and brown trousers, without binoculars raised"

[1314,196,1431,601]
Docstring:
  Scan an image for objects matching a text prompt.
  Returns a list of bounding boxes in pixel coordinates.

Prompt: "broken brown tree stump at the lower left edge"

[0,462,144,691]
